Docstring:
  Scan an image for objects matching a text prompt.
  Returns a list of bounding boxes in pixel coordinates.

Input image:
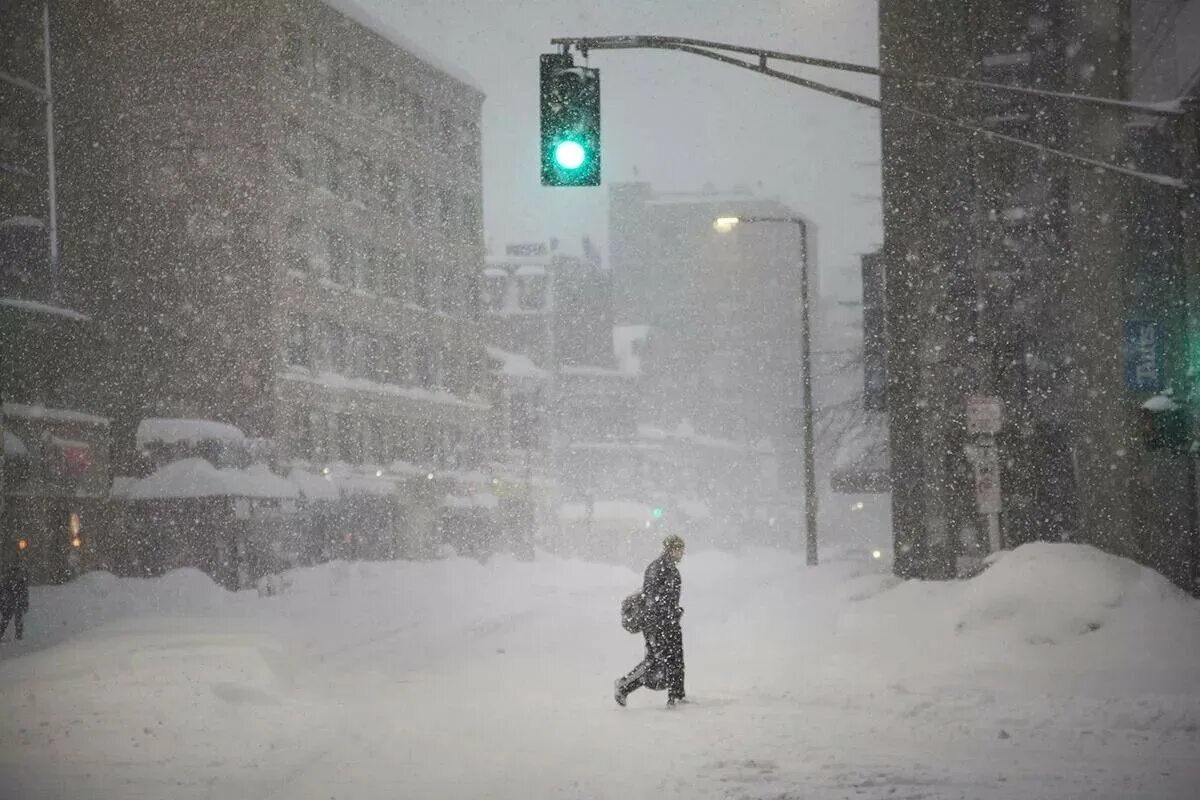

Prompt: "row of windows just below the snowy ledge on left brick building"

[287,409,481,469]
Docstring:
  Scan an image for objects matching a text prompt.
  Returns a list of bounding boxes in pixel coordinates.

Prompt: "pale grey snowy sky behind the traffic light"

[343,0,882,296]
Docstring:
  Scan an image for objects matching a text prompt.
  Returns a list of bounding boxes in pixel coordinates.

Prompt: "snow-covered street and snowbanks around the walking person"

[0,545,1200,800]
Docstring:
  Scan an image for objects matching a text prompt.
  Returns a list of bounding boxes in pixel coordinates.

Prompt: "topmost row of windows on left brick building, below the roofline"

[280,29,480,160]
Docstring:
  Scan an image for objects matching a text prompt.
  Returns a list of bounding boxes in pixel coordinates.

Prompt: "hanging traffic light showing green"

[540,53,600,186]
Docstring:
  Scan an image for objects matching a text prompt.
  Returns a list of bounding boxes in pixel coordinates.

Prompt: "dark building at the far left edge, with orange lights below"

[0,0,109,582]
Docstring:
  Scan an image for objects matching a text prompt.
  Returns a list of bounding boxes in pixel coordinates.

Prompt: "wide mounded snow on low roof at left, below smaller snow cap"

[113,458,300,500]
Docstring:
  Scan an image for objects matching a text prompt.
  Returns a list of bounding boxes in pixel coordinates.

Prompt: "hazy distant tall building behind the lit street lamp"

[608,184,820,455]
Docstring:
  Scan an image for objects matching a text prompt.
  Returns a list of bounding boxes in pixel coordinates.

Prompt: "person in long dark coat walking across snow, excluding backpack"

[613,535,686,708]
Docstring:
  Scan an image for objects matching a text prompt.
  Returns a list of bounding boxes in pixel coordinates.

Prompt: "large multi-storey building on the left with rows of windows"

[46,0,487,482]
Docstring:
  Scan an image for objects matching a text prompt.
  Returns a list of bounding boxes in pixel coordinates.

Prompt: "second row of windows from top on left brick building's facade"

[282,121,482,230]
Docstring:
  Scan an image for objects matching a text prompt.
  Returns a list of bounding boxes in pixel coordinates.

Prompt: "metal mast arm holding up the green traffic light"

[551,36,1200,190]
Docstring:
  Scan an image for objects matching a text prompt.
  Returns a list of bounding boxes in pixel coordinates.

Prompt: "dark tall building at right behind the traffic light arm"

[880,0,1187,587]
